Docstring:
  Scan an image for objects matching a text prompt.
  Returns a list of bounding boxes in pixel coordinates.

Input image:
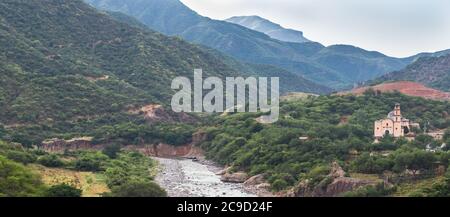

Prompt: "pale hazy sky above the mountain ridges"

[181,0,450,57]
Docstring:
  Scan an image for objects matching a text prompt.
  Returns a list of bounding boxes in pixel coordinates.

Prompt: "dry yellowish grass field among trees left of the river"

[30,164,110,197]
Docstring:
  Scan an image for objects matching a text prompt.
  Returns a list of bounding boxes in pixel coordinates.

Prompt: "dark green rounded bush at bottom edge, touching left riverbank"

[108,181,167,197]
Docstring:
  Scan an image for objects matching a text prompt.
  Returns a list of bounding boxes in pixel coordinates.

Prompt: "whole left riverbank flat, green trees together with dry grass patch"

[0,141,162,197]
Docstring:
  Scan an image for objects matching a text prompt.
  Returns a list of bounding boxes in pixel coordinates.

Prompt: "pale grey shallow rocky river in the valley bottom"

[153,158,256,197]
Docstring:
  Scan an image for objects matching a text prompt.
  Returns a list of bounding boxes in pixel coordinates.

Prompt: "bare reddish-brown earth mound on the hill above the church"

[338,81,450,100]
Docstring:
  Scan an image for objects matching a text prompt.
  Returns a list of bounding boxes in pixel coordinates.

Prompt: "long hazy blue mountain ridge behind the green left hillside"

[85,0,450,89]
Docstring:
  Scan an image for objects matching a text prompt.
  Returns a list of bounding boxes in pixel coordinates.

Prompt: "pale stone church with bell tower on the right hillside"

[374,103,420,139]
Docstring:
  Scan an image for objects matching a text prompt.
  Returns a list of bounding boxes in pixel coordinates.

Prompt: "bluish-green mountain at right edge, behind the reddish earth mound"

[375,55,450,92]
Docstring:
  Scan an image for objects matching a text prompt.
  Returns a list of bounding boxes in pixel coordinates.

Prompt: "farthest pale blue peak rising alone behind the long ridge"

[225,16,310,43]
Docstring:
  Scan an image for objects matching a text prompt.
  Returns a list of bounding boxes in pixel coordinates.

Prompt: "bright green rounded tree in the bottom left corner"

[0,156,44,197]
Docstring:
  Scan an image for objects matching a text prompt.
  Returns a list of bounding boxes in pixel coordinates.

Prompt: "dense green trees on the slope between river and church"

[201,91,450,194]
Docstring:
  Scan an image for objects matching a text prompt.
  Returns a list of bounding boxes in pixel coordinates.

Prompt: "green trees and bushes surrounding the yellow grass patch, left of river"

[0,141,167,197]
